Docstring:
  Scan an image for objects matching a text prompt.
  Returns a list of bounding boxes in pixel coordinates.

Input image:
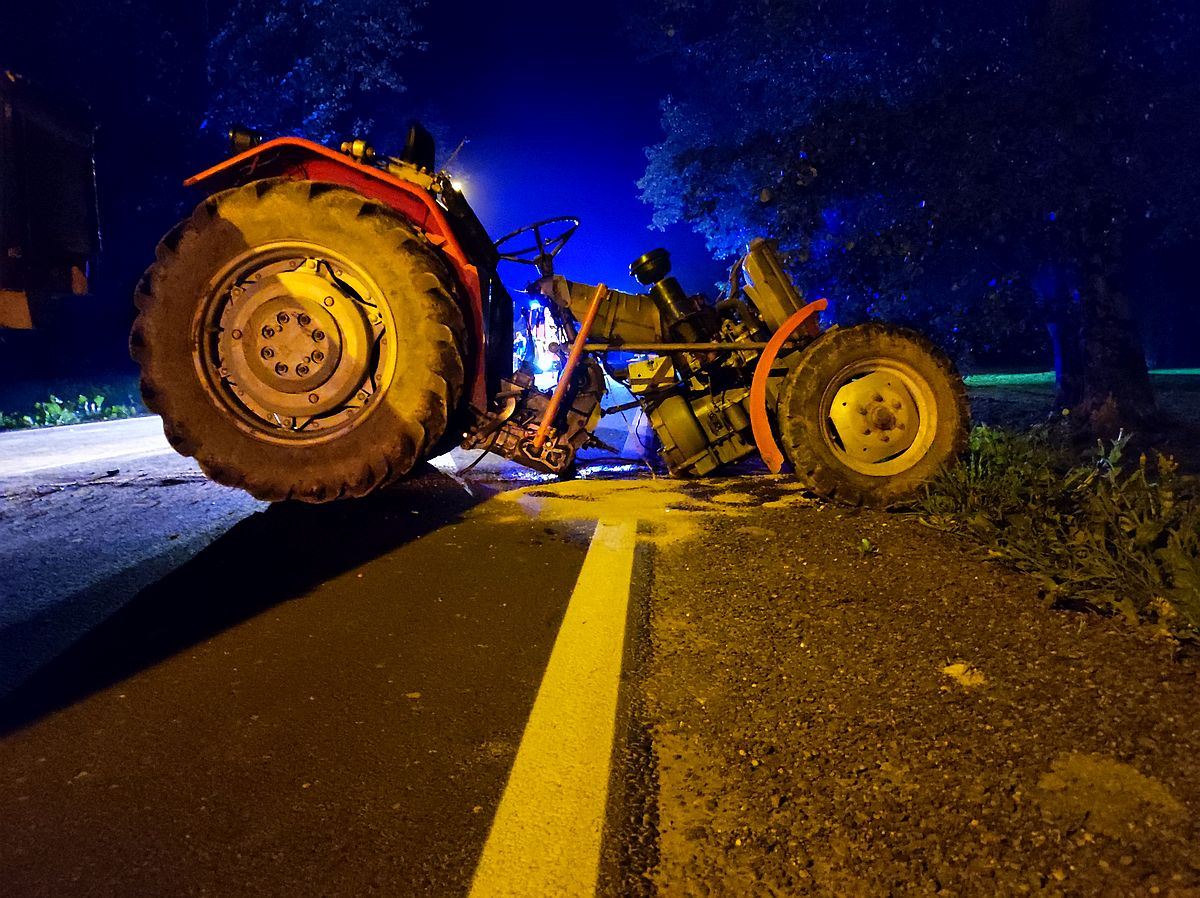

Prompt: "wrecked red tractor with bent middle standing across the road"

[130,125,967,505]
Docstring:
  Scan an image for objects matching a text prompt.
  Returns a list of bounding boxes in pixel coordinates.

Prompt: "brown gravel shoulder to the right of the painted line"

[637,374,1200,898]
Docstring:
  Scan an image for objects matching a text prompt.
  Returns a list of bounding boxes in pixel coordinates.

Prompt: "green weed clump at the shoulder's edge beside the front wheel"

[918,426,1200,640]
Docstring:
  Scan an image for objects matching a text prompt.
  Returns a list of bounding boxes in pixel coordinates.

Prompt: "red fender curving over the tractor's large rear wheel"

[184,137,487,408]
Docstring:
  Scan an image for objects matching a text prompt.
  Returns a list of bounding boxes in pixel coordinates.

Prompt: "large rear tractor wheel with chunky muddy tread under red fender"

[130,179,464,502]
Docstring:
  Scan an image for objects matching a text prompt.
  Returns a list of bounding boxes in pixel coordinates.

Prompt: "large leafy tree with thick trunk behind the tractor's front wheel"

[641,0,1200,429]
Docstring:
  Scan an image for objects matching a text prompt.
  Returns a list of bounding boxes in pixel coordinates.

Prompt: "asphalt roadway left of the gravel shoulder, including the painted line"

[0,419,657,896]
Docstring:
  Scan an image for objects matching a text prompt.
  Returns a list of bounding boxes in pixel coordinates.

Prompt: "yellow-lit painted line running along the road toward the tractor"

[470,521,637,898]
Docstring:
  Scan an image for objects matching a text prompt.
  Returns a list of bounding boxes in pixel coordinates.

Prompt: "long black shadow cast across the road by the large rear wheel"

[0,467,493,736]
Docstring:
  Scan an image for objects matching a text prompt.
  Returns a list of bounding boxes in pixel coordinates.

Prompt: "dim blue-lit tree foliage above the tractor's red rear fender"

[205,0,426,140]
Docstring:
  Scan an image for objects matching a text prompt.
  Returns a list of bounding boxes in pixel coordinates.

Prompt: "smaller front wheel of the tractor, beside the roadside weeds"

[776,323,968,507]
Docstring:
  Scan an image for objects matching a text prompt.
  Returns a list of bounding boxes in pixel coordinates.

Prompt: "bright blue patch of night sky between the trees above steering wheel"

[408,1,727,295]
